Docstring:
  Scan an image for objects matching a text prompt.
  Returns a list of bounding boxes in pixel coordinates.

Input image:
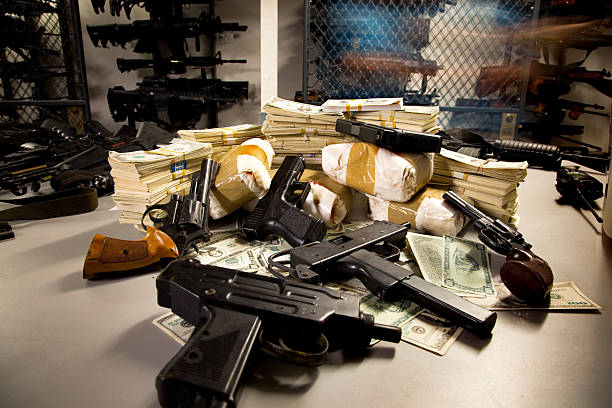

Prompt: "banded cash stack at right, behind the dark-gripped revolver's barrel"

[430,149,527,227]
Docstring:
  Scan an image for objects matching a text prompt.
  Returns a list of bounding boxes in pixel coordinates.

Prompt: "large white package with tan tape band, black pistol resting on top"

[322,142,433,202]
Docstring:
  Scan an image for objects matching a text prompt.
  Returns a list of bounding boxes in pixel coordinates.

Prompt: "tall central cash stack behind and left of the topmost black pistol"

[261,96,356,169]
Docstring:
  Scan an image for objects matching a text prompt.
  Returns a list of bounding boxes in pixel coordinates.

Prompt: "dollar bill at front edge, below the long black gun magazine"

[402,310,463,356]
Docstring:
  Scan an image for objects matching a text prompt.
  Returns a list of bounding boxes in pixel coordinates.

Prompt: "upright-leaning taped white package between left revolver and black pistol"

[210,139,274,219]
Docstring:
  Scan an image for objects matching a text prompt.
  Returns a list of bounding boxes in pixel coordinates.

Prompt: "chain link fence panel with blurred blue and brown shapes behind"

[302,0,535,132]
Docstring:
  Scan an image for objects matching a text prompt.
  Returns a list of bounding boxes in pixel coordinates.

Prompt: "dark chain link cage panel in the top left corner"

[0,0,89,130]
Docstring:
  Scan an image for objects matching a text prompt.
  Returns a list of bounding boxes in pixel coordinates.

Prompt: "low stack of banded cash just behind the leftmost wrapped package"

[177,124,263,155]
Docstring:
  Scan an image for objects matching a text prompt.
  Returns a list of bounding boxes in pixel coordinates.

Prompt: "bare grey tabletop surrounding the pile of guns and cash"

[0,169,612,408]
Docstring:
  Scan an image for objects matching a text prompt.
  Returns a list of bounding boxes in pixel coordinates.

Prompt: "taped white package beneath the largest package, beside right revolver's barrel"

[368,187,469,236]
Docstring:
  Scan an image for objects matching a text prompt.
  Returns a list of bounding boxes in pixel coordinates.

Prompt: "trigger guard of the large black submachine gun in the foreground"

[259,330,329,367]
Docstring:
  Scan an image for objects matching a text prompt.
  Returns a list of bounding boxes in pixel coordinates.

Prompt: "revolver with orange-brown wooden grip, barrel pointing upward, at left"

[83,159,219,279]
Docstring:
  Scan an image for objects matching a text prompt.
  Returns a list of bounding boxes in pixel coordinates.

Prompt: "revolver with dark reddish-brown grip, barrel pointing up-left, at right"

[442,191,553,304]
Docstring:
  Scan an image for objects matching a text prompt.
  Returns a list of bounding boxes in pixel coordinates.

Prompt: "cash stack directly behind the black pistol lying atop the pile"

[351,106,440,133]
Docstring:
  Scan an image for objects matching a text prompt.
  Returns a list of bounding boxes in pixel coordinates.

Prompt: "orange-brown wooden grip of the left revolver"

[83,227,178,279]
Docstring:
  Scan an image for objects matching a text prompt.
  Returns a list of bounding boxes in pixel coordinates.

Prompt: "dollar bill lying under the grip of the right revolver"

[467,282,601,311]
